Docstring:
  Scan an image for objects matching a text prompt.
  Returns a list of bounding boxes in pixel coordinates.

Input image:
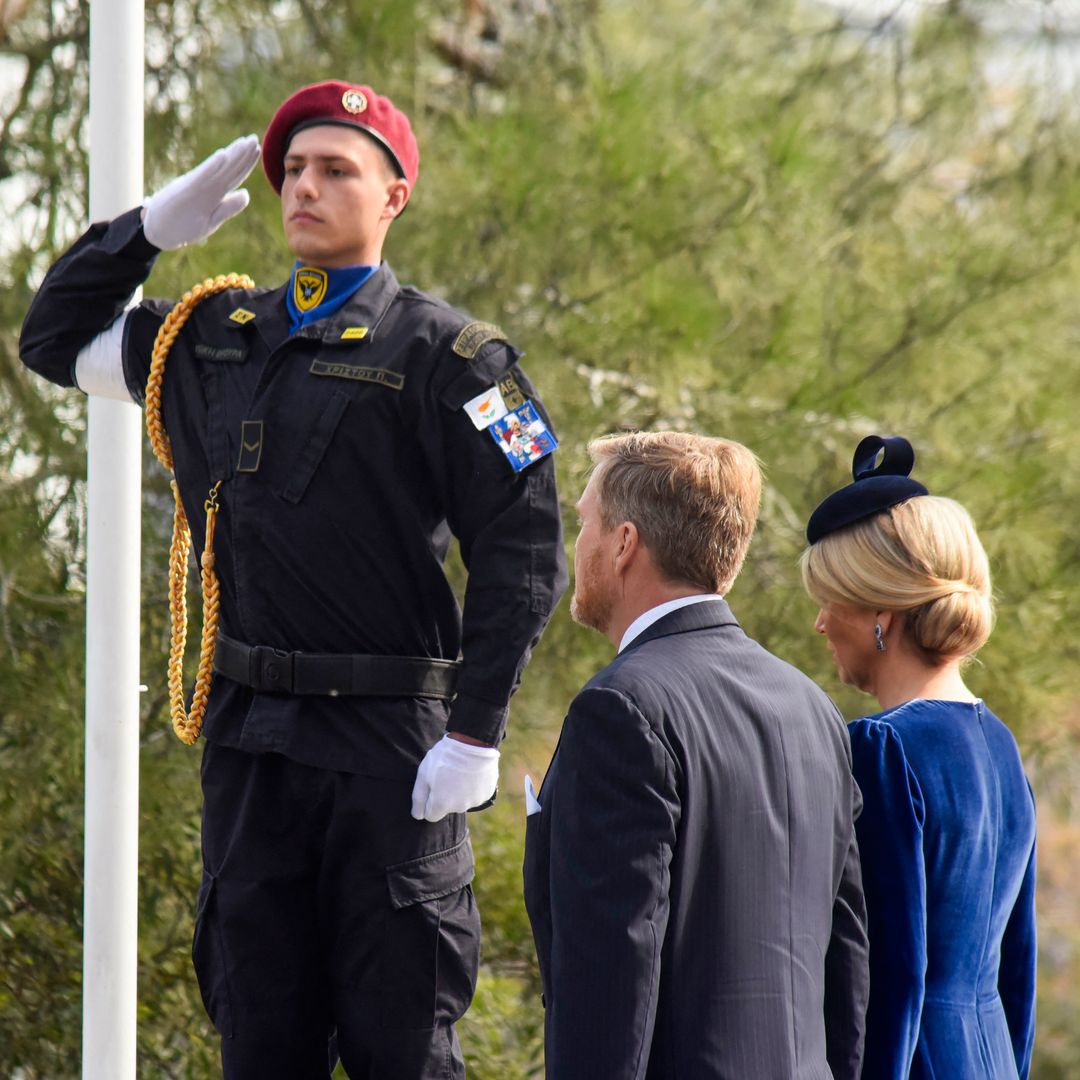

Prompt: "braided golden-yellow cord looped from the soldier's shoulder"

[146,273,255,746]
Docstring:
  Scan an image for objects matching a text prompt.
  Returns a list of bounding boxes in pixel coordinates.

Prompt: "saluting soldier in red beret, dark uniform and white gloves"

[21,82,566,1080]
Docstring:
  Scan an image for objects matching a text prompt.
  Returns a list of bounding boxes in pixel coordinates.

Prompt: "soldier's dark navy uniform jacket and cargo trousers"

[21,211,566,1080]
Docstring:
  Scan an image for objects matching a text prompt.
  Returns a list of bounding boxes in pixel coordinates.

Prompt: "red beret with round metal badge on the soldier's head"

[262,81,420,194]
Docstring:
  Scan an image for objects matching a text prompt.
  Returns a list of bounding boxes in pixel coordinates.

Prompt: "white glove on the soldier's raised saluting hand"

[143,135,259,252]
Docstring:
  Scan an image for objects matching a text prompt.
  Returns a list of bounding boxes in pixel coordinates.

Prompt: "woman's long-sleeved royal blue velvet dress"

[849,701,1036,1080]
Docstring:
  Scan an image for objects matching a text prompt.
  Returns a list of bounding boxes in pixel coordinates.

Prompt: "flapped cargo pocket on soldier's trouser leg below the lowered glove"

[379,836,480,1028]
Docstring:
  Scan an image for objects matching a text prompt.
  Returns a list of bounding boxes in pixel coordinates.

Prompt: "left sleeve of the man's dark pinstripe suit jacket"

[544,689,679,1080]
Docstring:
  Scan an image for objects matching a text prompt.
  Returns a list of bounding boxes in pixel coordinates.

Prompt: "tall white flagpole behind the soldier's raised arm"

[82,0,144,1080]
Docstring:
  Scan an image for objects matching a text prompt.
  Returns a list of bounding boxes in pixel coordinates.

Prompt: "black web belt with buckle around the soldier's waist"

[214,634,459,701]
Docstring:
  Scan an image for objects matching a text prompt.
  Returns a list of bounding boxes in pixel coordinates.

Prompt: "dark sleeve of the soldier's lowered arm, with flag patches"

[429,342,567,745]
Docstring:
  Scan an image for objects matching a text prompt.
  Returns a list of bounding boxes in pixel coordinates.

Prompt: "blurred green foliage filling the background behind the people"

[0,0,1080,1078]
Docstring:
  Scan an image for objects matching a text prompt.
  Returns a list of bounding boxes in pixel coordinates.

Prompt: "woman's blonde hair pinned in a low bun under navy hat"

[801,495,994,662]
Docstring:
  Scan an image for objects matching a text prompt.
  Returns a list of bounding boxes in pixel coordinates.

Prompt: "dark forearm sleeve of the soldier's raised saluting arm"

[18,208,159,396]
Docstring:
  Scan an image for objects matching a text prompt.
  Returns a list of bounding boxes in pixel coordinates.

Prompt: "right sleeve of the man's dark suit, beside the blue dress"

[825,762,870,1080]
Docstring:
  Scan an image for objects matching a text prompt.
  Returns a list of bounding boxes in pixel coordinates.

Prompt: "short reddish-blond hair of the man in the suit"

[589,431,761,596]
